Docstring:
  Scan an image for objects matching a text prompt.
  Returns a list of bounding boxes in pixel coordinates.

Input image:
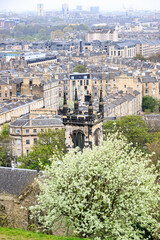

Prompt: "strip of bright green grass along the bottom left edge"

[0,227,89,240]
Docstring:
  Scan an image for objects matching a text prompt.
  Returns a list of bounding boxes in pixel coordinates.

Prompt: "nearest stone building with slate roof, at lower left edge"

[0,167,38,229]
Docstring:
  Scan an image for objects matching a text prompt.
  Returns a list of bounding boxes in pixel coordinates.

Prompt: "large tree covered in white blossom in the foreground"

[31,134,160,240]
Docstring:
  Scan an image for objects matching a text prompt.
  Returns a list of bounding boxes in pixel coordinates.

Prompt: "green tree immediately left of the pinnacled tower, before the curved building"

[17,129,65,170]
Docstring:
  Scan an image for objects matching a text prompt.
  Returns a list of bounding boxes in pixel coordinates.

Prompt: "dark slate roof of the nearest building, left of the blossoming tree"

[0,167,38,196]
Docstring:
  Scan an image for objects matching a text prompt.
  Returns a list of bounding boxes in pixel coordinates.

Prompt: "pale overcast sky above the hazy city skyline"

[0,0,160,11]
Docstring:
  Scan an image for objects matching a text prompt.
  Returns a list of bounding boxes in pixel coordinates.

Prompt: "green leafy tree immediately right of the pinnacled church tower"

[103,115,150,148]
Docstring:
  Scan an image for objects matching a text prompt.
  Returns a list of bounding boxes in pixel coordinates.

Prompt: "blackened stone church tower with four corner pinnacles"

[63,89,104,151]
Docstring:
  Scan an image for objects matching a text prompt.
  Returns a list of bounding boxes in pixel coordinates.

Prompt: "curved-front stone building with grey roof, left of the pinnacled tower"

[9,109,64,157]
